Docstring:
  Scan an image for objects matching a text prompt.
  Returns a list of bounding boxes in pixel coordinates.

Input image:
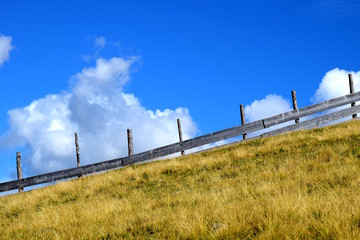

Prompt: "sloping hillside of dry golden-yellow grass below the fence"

[0,121,360,239]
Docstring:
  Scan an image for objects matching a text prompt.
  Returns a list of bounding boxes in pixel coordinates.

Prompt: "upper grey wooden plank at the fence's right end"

[263,92,360,128]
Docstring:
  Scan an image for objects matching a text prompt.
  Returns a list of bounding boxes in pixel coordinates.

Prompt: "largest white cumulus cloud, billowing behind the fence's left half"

[0,58,197,174]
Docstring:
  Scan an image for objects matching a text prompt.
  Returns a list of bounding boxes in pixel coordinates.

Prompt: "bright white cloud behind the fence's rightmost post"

[311,68,360,103]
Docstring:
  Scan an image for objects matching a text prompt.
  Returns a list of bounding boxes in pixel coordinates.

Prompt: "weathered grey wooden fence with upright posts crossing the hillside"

[0,74,360,192]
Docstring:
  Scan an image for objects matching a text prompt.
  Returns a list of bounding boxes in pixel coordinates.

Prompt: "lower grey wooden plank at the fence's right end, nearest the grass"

[261,105,360,137]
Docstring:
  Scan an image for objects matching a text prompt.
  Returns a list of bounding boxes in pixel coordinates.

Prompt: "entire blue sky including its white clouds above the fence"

[0,0,360,183]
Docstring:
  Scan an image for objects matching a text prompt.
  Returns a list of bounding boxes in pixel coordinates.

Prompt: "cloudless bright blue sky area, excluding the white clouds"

[0,0,360,178]
